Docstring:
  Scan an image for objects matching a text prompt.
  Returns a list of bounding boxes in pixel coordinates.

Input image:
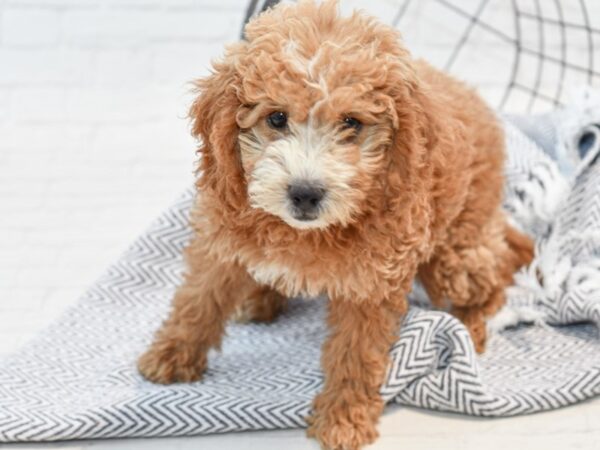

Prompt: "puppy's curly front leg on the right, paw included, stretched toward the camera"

[308,296,406,450]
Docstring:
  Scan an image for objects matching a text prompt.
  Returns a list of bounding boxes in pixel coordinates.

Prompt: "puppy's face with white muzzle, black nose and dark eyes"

[238,86,391,229]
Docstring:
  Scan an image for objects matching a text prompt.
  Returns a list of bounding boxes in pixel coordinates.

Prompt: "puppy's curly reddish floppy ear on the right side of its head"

[388,61,470,241]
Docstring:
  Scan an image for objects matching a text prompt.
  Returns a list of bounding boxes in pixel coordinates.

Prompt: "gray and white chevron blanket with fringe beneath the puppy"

[0,97,600,442]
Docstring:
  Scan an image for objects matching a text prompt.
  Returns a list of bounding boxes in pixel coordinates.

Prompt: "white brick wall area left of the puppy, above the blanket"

[0,0,244,354]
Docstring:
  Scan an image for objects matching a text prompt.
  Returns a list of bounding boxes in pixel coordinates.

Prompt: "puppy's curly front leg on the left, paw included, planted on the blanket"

[138,247,256,384]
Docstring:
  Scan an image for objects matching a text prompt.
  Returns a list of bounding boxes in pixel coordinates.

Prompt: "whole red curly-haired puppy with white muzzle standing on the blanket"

[139,1,532,450]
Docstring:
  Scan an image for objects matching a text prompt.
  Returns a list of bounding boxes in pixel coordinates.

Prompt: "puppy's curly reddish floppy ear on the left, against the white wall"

[189,43,246,209]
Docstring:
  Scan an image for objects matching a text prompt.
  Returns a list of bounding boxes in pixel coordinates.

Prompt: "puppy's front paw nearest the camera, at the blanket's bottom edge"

[307,394,378,450]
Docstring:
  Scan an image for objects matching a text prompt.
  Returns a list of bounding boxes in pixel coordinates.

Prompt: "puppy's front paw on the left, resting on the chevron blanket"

[138,340,206,384]
